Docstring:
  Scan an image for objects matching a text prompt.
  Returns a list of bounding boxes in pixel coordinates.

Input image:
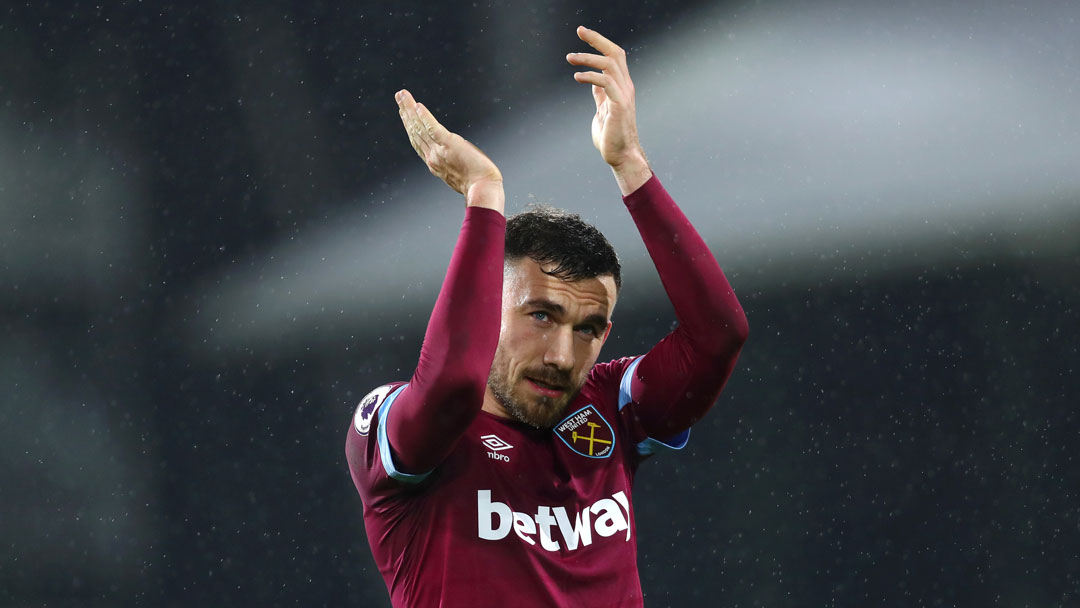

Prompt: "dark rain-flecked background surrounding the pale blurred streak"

[0,1,1080,606]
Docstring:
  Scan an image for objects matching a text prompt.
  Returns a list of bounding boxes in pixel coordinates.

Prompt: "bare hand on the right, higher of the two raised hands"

[566,26,652,194]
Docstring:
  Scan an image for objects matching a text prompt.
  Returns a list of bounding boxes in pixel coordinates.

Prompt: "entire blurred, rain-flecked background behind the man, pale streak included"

[0,0,1080,607]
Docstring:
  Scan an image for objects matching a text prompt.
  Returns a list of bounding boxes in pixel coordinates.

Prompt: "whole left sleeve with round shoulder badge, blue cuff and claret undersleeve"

[346,206,507,495]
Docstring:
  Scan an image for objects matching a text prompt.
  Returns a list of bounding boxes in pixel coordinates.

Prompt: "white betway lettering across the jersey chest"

[476,490,630,551]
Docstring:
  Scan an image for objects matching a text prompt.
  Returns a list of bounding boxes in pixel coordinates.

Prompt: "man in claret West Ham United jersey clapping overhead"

[346,27,747,607]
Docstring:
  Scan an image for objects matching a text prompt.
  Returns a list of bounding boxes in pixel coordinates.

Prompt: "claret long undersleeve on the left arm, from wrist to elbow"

[387,206,505,473]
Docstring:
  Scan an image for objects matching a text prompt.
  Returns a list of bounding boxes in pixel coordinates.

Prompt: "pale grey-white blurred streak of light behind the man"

[192,2,1080,352]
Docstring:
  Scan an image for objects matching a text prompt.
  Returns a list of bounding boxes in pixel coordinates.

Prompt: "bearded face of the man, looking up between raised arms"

[487,257,616,429]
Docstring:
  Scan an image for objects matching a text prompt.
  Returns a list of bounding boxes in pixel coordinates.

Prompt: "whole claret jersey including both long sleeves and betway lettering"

[346,176,746,608]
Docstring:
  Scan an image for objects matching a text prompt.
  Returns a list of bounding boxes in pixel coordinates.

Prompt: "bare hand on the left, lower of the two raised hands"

[394,89,503,213]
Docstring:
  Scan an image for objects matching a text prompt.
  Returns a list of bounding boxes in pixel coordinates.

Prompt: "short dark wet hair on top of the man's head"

[505,204,622,291]
